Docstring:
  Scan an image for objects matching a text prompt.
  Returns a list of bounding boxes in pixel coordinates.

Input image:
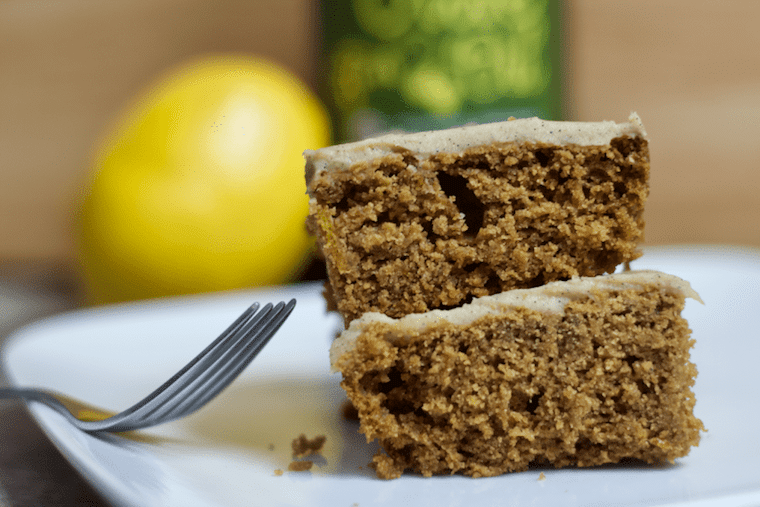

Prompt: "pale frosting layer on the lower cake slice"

[330,271,702,367]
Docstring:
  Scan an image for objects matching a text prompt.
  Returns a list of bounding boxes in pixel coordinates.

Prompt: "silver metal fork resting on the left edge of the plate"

[0,299,296,433]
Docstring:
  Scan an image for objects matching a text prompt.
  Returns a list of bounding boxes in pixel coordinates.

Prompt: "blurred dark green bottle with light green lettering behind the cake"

[321,0,562,142]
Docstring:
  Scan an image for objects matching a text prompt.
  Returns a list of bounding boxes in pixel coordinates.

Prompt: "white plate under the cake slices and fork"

[4,247,760,507]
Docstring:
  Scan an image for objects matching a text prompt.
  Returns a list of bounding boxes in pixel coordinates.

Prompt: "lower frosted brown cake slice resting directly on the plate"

[330,271,703,478]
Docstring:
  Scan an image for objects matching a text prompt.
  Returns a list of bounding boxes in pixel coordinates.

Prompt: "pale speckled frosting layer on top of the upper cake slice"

[304,113,646,192]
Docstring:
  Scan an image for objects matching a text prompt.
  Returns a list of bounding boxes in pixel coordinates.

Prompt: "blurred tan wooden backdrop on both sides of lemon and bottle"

[0,0,760,286]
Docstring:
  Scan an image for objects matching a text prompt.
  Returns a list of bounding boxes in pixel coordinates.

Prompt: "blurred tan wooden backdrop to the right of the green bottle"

[568,0,760,246]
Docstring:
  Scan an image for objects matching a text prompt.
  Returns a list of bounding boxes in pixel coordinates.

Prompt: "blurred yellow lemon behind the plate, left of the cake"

[77,55,330,303]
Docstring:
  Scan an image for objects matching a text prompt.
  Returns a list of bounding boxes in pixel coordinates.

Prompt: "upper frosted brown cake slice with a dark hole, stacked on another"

[305,114,649,322]
